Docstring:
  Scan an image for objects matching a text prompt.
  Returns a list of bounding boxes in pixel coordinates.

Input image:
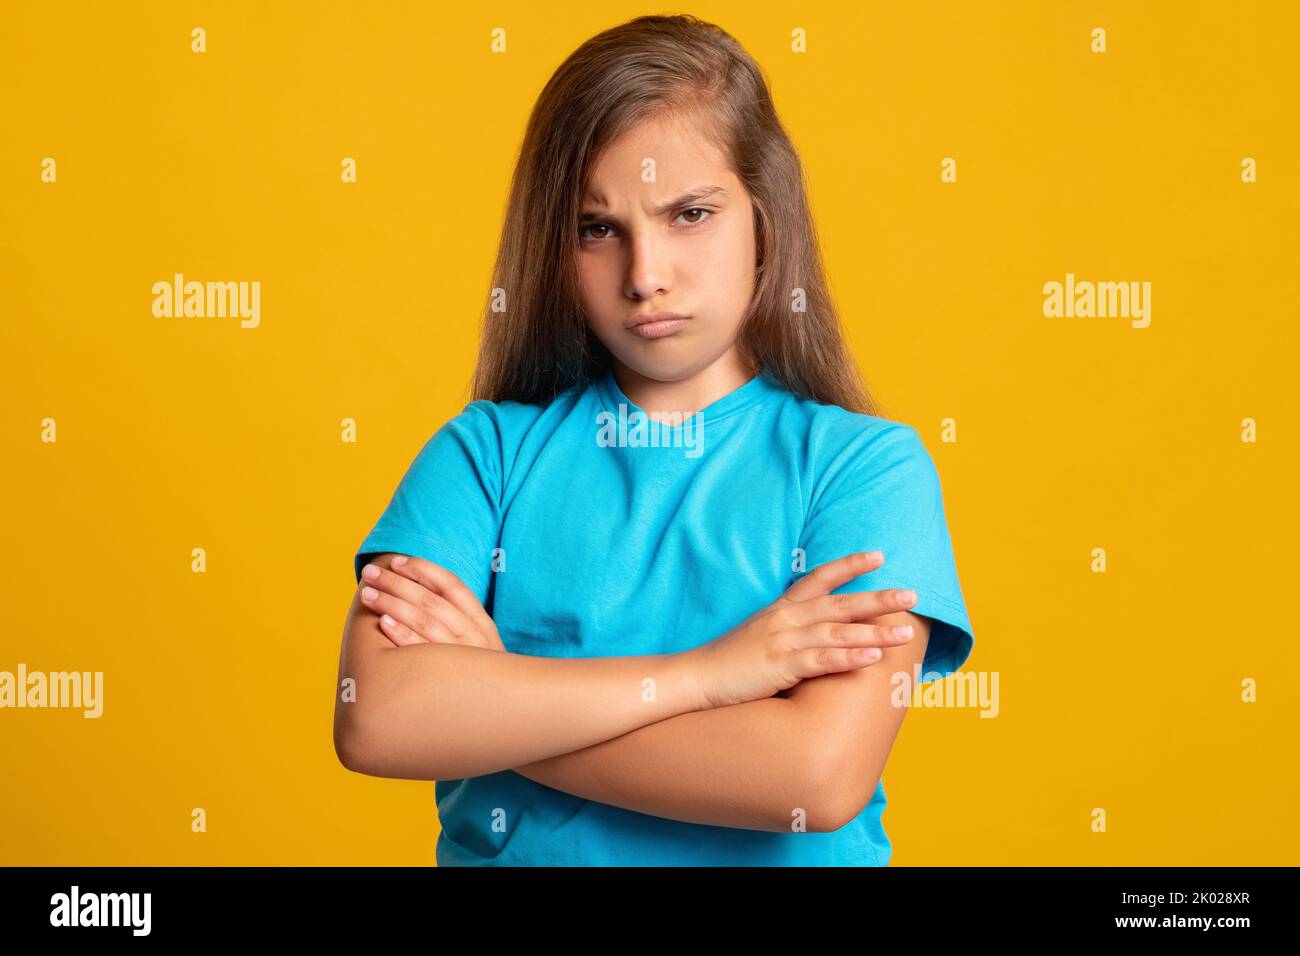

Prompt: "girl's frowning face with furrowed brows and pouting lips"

[577,117,757,382]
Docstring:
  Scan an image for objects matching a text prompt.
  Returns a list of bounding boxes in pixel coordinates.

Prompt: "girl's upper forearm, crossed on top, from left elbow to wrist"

[342,644,709,780]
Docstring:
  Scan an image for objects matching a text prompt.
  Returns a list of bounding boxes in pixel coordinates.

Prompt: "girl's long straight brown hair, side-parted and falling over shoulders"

[472,14,879,415]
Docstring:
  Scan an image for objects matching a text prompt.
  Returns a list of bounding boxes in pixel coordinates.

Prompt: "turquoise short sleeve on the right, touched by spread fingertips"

[801,420,975,683]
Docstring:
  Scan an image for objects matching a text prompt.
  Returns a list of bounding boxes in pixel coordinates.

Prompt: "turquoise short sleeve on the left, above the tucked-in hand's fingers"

[352,402,502,607]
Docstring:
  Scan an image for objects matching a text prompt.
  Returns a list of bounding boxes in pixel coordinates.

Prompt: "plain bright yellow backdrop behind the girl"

[0,0,1300,865]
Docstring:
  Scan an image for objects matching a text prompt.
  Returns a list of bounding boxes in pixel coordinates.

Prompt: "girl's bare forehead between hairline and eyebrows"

[586,113,735,203]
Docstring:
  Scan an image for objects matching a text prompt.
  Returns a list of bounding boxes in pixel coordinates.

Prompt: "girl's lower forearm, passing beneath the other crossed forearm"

[514,697,837,832]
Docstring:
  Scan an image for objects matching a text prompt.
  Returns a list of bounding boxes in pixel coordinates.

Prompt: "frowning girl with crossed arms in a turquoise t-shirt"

[334,16,974,866]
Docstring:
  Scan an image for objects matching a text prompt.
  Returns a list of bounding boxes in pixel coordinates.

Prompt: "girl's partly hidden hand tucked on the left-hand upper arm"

[361,554,506,650]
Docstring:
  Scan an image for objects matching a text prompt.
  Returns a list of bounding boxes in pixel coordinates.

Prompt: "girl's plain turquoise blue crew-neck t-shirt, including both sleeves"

[354,372,975,866]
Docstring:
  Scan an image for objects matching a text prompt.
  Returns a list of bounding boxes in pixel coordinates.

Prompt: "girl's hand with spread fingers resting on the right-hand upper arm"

[686,551,917,708]
